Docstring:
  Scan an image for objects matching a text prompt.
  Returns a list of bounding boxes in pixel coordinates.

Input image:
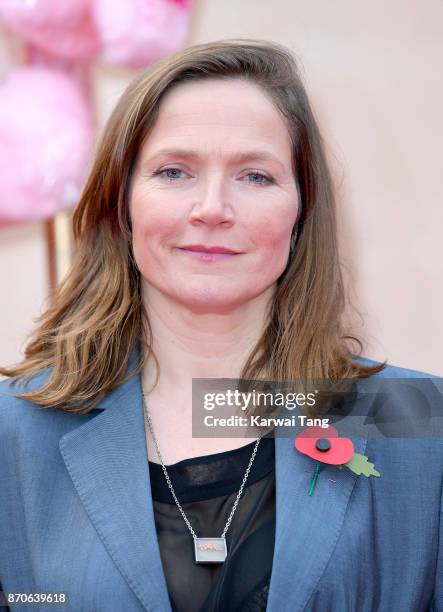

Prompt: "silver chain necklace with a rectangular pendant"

[143,393,261,563]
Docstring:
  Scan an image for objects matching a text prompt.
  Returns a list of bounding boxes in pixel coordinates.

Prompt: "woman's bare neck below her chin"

[142,286,274,394]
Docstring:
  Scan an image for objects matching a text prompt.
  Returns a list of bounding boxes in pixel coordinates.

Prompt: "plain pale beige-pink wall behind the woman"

[0,0,443,375]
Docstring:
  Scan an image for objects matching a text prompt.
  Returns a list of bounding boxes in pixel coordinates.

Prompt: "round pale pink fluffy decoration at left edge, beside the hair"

[0,67,93,221]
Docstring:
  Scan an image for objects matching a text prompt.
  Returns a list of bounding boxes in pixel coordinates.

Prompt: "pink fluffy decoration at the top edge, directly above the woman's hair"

[92,0,190,68]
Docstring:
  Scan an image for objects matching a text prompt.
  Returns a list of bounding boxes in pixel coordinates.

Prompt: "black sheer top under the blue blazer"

[149,432,275,612]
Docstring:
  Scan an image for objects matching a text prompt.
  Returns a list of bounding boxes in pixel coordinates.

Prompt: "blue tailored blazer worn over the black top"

[0,358,443,612]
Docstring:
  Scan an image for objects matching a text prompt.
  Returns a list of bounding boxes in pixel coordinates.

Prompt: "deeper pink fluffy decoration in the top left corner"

[0,0,99,61]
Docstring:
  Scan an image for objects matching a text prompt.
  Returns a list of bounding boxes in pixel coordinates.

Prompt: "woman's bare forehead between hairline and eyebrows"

[143,79,291,157]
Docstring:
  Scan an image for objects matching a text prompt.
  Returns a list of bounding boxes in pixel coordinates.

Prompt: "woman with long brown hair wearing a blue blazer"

[0,40,443,612]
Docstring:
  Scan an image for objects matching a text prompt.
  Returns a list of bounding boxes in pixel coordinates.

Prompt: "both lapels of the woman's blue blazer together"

[59,357,366,612]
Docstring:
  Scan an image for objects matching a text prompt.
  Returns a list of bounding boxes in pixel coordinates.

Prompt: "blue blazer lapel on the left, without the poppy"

[59,368,171,612]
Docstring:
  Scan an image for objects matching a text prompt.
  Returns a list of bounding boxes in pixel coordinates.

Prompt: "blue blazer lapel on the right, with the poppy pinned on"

[267,427,367,612]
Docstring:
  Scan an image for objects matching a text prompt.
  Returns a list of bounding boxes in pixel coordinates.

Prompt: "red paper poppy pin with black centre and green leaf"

[294,425,380,495]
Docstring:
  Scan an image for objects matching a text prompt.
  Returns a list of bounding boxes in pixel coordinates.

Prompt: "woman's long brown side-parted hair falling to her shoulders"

[0,39,386,414]
